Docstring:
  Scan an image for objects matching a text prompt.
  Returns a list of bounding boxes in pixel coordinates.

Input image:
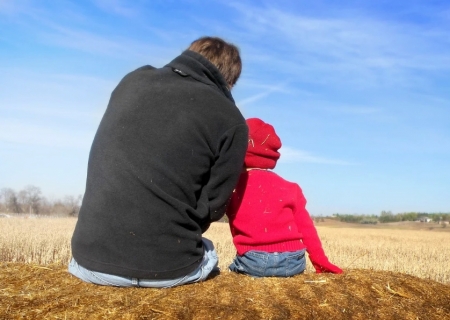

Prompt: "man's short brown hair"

[188,37,242,88]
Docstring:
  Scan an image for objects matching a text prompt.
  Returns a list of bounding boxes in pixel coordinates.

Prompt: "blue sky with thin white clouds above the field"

[0,0,450,215]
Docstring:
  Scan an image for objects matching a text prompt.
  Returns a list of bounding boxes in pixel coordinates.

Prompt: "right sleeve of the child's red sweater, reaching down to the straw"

[294,185,342,273]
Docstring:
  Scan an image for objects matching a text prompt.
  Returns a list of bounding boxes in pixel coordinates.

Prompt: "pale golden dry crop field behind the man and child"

[0,218,450,284]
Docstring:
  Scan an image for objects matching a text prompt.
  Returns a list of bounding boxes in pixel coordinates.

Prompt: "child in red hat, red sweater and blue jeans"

[227,118,342,277]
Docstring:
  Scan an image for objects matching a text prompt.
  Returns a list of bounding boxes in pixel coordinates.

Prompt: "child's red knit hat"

[245,118,281,169]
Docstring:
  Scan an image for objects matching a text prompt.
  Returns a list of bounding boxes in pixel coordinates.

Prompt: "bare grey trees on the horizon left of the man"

[0,185,82,216]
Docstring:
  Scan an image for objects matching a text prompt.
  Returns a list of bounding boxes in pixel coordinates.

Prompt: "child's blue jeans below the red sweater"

[229,250,306,278]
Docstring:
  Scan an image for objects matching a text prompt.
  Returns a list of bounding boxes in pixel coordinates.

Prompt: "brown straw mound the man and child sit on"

[0,263,450,320]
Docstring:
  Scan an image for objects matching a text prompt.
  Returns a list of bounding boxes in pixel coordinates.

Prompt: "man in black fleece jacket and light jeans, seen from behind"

[69,37,248,287]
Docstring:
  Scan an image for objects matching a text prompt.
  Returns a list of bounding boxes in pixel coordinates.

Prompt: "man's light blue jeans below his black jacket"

[69,238,219,288]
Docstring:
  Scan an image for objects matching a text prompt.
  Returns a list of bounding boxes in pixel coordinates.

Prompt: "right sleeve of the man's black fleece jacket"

[199,123,248,232]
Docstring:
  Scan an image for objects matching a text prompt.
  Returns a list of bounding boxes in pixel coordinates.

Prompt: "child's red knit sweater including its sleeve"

[227,169,342,273]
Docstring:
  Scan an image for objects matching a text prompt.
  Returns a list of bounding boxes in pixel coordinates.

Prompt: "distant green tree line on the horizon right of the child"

[333,211,450,224]
